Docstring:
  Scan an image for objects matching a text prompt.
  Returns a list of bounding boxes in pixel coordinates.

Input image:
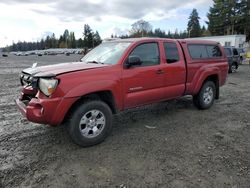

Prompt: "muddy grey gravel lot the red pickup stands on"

[0,55,250,188]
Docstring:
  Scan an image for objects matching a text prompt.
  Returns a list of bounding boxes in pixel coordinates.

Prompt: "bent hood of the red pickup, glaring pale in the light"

[22,62,108,77]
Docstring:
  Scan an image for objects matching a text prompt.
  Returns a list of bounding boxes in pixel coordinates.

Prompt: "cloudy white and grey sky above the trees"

[0,0,212,47]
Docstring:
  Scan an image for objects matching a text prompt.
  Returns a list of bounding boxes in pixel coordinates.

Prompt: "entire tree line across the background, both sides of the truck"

[3,0,250,51]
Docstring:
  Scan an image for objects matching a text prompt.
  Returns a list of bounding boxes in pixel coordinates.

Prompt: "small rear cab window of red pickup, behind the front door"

[164,42,180,63]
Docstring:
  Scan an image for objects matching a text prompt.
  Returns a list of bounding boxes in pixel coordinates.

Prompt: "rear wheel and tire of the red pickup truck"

[193,81,216,110]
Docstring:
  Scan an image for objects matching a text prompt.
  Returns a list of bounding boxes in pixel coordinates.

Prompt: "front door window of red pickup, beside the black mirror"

[130,43,160,66]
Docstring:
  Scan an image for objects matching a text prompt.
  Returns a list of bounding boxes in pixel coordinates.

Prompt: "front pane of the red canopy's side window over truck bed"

[188,44,208,59]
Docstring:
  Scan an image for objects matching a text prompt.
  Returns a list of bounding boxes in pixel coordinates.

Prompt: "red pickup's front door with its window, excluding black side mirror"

[123,42,164,109]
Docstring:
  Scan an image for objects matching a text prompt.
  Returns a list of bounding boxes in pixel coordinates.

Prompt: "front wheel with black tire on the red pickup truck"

[67,100,113,147]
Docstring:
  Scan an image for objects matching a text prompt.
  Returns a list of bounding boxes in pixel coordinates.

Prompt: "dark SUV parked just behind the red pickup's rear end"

[224,47,240,73]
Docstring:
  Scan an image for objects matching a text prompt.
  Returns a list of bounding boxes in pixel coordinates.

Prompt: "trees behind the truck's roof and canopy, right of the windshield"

[118,0,250,41]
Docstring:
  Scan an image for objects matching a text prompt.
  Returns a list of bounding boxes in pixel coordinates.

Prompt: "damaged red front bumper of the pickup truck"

[15,95,77,126]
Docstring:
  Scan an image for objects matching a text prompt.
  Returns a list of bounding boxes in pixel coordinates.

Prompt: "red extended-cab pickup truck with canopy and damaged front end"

[16,38,228,146]
